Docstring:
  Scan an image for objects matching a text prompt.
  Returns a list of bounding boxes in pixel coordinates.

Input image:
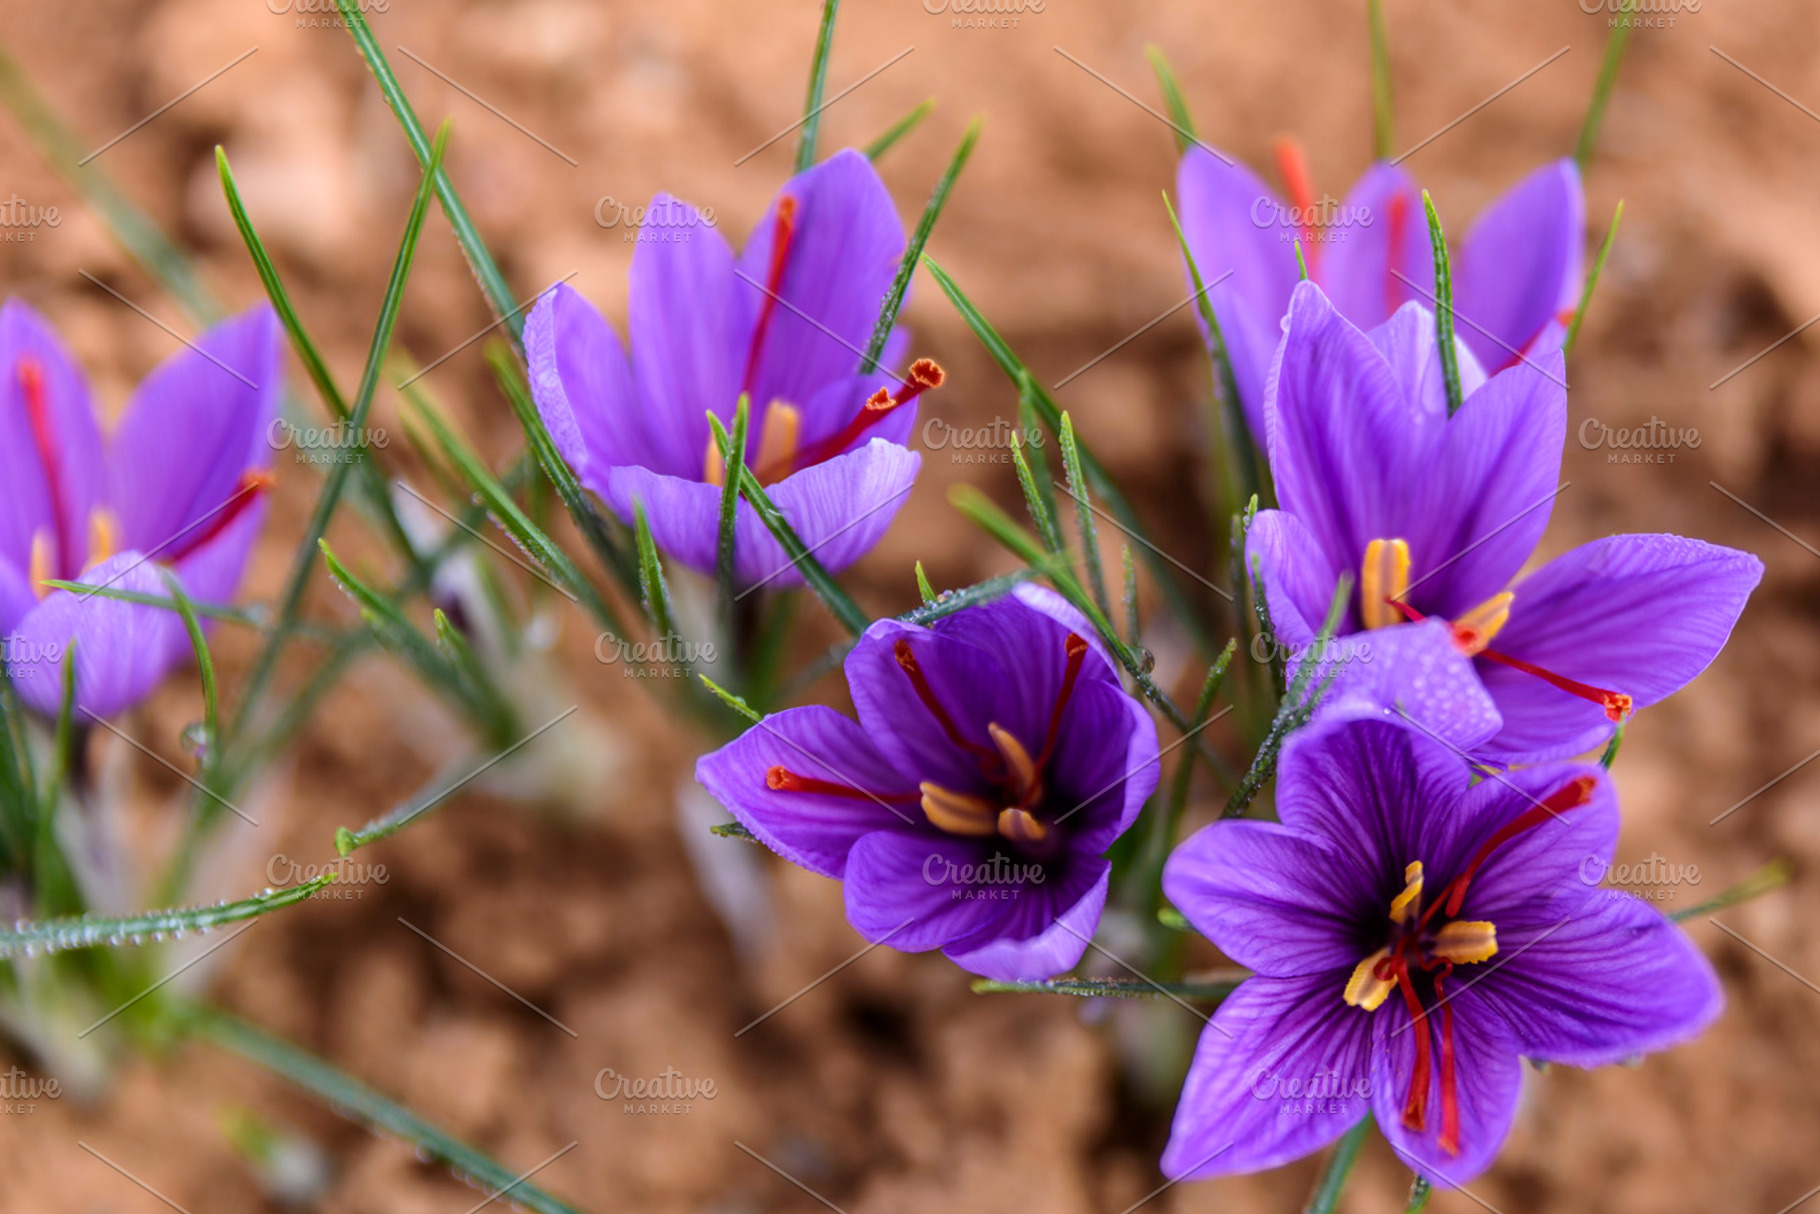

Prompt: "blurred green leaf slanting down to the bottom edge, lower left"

[187,1007,581,1214]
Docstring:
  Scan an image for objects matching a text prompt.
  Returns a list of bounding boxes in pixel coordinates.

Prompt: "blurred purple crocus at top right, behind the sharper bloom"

[1176,140,1585,440]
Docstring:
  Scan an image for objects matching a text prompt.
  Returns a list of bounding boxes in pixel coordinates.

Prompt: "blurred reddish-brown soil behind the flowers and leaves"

[0,0,1820,1214]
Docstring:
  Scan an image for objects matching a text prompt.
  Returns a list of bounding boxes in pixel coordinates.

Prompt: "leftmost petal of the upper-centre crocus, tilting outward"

[524,282,647,497]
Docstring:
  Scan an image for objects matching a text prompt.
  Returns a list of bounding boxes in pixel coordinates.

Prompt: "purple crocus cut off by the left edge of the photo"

[0,300,280,717]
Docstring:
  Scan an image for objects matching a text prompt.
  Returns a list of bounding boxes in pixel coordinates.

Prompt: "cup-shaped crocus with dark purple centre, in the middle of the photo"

[695,588,1159,981]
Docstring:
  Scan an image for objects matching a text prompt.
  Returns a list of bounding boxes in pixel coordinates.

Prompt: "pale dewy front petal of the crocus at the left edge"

[7,551,189,723]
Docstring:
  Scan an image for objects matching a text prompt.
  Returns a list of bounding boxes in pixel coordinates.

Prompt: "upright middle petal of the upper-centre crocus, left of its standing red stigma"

[621,193,744,479]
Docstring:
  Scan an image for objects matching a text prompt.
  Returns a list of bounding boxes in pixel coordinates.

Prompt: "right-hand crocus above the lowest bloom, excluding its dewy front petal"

[1245,282,1764,763]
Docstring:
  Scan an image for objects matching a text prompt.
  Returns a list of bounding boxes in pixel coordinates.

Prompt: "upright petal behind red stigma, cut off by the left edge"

[0,298,104,589]
